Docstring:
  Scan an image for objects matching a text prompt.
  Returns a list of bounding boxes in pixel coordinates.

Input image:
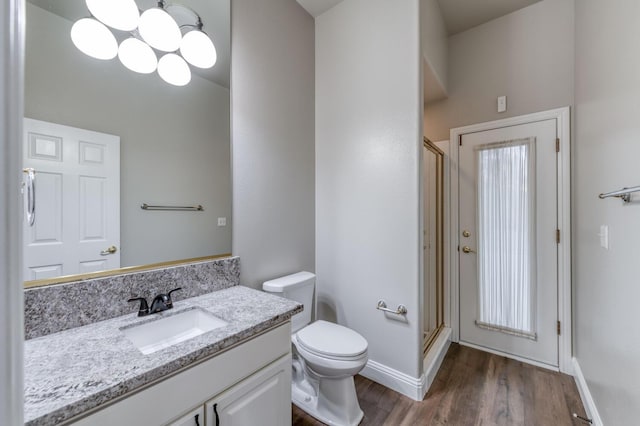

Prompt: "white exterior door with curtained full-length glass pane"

[458,119,558,367]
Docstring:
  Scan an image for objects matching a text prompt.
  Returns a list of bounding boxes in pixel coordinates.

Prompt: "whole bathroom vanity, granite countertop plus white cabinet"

[25,286,302,426]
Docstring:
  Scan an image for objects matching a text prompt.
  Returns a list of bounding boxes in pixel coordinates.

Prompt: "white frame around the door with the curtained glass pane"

[449,106,573,374]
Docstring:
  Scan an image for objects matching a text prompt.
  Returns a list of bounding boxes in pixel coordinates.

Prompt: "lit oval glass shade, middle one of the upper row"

[138,7,182,52]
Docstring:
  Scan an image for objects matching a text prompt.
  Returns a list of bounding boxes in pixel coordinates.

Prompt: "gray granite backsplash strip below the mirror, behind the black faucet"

[24,257,240,339]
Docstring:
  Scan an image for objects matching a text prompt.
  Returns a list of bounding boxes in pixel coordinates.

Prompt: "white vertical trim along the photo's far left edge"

[0,0,25,425]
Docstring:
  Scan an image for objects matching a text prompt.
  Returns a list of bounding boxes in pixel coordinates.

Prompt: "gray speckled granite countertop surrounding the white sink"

[24,286,302,426]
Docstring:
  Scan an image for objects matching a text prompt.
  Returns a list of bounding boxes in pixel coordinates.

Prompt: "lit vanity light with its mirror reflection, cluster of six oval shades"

[71,0,217,86]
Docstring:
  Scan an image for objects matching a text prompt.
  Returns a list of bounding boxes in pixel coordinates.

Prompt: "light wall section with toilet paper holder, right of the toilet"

[316,0,422,390]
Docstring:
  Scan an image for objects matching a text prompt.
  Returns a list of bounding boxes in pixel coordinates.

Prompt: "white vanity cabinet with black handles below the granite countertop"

[71,322,291,426]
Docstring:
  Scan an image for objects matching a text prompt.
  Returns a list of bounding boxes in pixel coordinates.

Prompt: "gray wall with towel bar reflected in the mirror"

[25,4,231,266]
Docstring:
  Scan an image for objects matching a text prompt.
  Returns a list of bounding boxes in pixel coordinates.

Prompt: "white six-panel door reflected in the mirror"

[23,118,120,280]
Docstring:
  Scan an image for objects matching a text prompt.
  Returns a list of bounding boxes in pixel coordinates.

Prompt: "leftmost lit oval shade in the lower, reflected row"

[71,18,118,60]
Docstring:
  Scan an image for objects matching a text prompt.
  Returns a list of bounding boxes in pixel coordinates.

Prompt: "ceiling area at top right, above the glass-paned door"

[437,0,540,35]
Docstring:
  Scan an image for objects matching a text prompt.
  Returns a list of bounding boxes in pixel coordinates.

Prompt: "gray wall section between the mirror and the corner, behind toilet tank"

[231,0,315,288]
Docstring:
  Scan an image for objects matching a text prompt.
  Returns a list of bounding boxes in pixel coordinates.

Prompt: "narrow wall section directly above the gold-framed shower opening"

[420,0,449,102]
